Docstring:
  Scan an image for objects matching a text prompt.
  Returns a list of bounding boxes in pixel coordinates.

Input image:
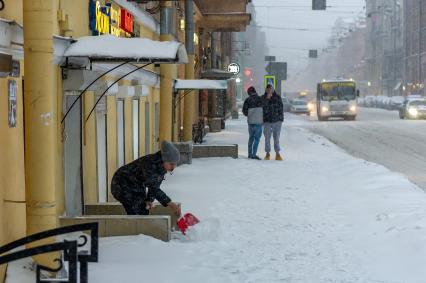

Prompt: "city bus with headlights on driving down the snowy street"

[317,79,359,121]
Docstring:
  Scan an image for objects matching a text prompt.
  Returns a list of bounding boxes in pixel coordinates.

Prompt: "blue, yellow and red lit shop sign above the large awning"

[89,0,133,37]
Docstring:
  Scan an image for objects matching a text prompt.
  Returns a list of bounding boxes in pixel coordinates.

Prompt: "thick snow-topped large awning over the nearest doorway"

[64,35,188,64]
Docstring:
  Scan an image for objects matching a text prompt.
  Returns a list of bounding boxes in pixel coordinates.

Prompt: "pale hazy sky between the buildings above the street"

[252,0,365,75]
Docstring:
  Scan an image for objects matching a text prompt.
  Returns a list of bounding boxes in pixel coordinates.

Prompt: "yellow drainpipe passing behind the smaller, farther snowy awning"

[183,0,195,141]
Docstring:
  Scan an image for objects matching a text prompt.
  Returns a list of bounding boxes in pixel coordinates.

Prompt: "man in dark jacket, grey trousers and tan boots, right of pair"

[262,85,284,160]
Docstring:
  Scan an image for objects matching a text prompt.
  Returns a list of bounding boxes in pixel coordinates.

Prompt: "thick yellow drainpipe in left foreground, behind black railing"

[23,0,61,266]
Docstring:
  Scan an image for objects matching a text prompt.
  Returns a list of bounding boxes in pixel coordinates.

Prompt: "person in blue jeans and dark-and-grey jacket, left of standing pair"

[243,86,263,160]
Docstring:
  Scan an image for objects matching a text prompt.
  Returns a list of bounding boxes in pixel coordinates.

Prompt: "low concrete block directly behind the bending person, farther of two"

[84,202,181,231]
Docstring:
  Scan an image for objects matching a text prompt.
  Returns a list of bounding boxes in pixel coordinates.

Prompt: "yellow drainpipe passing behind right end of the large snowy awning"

[159,1,177,141]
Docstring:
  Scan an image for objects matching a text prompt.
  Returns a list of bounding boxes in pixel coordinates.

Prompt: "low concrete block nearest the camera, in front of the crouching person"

[59,215,171,242]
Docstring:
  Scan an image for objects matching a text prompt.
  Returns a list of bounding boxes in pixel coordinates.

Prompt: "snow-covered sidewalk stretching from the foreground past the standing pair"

[7,116,426,283]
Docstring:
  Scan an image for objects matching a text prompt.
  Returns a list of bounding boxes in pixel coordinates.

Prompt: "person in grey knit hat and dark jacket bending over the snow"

[111,141,181,216]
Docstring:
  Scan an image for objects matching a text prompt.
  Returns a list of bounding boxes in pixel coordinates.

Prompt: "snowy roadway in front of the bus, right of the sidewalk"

[299,108,426,190]
